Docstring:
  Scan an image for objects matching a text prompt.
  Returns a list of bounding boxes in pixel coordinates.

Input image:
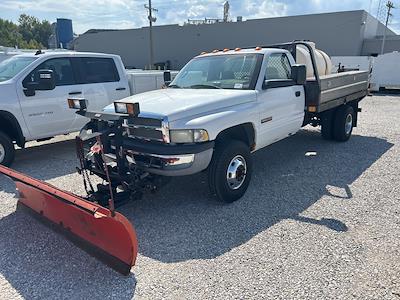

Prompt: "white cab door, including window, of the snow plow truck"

[258,53,305,147]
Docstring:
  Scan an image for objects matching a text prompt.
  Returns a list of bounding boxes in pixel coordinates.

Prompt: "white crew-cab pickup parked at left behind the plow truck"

[0,51,175,165]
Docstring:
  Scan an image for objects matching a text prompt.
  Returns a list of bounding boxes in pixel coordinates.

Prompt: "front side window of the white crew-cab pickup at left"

[23,58,76,87]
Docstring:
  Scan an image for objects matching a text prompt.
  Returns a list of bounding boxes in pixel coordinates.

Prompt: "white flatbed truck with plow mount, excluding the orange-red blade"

[70,42,369,205]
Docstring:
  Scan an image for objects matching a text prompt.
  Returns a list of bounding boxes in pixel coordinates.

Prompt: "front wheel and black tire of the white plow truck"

[208,140,253,203]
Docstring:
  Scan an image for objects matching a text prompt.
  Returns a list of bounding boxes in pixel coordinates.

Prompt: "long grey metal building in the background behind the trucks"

[74,10,400,69]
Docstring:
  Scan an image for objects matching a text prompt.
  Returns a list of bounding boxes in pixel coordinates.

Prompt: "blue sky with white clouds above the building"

[0,0,400,34]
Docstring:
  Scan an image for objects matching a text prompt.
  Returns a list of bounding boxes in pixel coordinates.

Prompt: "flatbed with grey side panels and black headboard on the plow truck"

[265,41,370,113]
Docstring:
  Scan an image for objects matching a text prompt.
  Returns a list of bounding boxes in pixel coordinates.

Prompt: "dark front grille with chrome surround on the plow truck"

[125,117,165,142]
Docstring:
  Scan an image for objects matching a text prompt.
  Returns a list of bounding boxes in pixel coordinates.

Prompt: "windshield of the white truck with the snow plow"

[169,54,262,90]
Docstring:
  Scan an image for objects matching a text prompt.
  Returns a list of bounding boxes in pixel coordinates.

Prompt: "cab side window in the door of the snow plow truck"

[265,53,292,80]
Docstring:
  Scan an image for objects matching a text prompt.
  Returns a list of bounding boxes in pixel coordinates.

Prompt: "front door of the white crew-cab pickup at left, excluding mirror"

[18,57,82,139]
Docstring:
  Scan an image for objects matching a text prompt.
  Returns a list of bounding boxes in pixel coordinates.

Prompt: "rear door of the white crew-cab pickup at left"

[72,57,130,131]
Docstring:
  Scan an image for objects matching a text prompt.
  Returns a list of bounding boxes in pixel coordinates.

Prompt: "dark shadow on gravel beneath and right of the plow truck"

[126,130,393,263]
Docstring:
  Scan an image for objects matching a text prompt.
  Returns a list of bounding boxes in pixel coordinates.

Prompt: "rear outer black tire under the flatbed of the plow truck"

[333,105,354,142]
